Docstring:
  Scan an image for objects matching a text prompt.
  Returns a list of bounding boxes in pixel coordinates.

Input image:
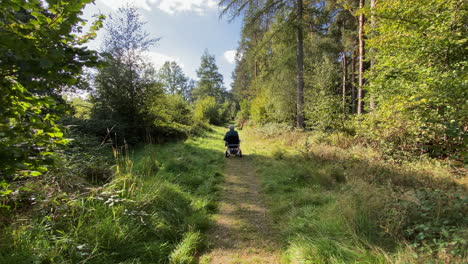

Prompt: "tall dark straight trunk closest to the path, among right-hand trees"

[296,0,304,128]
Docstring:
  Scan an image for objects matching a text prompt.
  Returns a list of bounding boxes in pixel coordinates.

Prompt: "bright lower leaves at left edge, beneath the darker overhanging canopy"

[0,81,67,180]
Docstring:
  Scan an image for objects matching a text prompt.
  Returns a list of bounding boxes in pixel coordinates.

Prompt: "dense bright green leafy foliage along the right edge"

[362,0,467,156]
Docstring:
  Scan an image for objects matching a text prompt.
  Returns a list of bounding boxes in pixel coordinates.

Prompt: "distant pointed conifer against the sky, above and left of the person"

[193,50,225,103]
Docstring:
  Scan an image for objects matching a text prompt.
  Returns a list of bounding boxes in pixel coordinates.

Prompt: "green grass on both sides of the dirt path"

[0,127,468,264]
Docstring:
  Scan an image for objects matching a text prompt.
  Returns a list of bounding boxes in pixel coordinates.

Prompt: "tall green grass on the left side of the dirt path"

[0,127,224,264]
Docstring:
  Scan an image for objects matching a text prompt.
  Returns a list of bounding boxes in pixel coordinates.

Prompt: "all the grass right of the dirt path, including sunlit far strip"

[242,126,468,264]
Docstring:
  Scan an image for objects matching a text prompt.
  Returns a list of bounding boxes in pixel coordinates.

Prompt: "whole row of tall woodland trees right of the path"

[225,0,467,156]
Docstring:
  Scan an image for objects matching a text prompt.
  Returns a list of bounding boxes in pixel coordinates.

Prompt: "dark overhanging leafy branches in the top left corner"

[0,0,104,95]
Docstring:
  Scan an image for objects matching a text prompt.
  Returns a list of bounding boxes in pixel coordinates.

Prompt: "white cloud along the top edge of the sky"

[101,0,217,14]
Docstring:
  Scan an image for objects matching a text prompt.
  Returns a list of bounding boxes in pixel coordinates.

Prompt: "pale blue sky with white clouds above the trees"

[84,0,241,90]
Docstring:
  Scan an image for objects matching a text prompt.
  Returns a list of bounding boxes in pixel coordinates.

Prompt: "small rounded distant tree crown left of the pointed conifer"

[158,61,188,94]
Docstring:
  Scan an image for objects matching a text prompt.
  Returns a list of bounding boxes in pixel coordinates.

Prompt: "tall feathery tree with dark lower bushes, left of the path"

[91,6,193,143]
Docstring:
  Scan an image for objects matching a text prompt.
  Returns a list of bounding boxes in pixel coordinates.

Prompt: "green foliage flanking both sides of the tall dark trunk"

[229,1,342,130]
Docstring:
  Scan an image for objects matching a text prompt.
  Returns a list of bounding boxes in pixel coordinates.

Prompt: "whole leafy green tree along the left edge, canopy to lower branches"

[0,0,104,179]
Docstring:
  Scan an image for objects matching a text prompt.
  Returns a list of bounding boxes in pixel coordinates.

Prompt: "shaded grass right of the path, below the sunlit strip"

[247,146,468,263]
